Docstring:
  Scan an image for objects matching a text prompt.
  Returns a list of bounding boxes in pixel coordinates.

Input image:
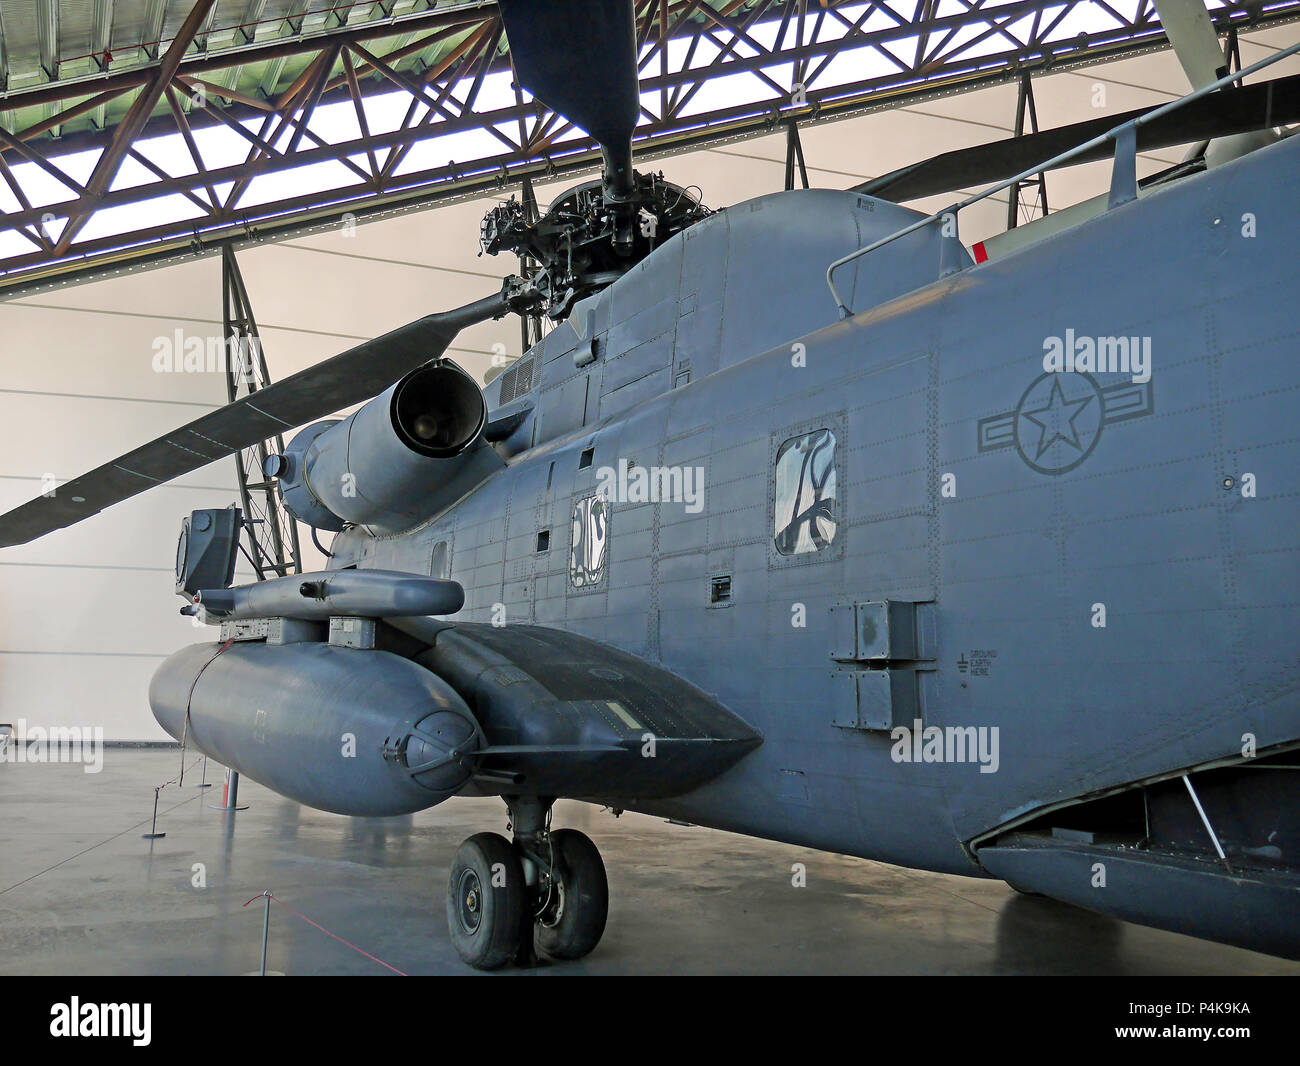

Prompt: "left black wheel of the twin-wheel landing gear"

[447,833,527,970]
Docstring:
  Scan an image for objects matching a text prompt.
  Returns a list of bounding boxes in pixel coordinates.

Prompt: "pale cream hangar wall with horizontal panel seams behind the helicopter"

[0,27,1300,740]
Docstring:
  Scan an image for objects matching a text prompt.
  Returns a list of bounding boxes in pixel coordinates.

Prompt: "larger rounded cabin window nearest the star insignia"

[772,429,839,555]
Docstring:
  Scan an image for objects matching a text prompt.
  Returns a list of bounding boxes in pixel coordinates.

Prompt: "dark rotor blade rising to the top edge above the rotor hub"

[498,0,641,192]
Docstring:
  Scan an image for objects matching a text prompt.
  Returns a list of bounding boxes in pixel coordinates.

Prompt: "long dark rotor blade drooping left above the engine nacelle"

[0,294,508,547]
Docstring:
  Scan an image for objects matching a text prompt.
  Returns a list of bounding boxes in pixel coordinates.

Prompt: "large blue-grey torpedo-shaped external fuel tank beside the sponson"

[150,641,482,815]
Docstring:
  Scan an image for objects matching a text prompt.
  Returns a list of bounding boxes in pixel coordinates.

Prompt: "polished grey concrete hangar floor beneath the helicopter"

[0,749,1300,975]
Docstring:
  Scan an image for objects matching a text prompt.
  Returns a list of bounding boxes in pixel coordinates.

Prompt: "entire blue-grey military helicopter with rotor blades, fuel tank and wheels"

[0,0,1300,969]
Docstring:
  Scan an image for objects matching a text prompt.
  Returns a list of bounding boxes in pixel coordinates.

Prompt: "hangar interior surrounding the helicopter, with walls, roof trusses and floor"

[0,0,1300,974]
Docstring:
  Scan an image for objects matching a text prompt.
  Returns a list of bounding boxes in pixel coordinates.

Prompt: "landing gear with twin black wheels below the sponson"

[447,796,610,970]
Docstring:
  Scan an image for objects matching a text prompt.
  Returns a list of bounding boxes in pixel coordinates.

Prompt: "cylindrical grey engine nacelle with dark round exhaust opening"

[265,360,506,533]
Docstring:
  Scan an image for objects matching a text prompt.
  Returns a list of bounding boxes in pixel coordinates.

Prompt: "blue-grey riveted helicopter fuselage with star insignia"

[332,133,1300,953]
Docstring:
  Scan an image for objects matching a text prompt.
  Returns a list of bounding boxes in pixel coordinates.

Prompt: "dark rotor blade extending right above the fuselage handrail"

[853,74,1300,203]
